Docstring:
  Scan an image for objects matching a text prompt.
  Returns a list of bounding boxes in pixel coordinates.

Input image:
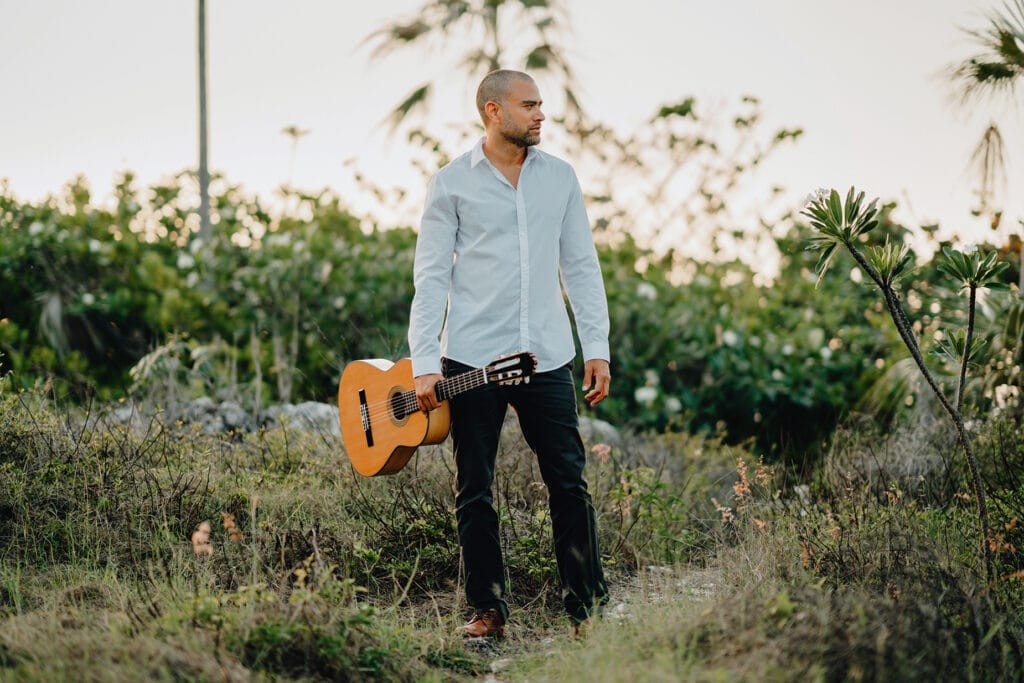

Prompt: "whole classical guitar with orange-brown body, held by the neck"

[338,351,537,476]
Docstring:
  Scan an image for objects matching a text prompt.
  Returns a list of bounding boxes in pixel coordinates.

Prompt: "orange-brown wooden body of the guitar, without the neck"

[338,358,452,476]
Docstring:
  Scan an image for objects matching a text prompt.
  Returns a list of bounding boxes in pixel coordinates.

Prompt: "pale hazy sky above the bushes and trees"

[0,0,1024,250]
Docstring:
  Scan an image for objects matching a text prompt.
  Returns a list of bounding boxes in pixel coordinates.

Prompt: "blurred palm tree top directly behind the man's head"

[365,0,583,132]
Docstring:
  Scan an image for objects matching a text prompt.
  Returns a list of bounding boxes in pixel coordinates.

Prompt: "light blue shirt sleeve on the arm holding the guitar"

[409,169,459,377]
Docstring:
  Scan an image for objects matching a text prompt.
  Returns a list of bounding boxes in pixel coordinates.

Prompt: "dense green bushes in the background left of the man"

[0,174,415,405]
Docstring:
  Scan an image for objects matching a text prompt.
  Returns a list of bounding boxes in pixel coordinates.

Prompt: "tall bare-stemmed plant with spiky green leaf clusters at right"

[802,187,1009,579]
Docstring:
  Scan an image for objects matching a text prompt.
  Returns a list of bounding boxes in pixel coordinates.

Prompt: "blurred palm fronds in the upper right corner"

[950,0,1024,293]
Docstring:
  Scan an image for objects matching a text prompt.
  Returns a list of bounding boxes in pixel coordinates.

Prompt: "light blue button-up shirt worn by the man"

[409,138,610,377]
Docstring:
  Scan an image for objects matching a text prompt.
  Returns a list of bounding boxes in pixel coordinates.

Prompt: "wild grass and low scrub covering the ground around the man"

[0,393,1024,681]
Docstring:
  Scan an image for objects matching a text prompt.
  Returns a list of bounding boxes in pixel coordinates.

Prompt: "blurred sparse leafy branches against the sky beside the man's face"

[568,95,803,273]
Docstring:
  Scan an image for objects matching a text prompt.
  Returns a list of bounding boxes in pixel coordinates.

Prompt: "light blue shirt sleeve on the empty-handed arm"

[559,171,611,361]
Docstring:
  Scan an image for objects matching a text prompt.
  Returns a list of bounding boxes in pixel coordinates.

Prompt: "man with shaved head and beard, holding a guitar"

[409,70,610,637]
